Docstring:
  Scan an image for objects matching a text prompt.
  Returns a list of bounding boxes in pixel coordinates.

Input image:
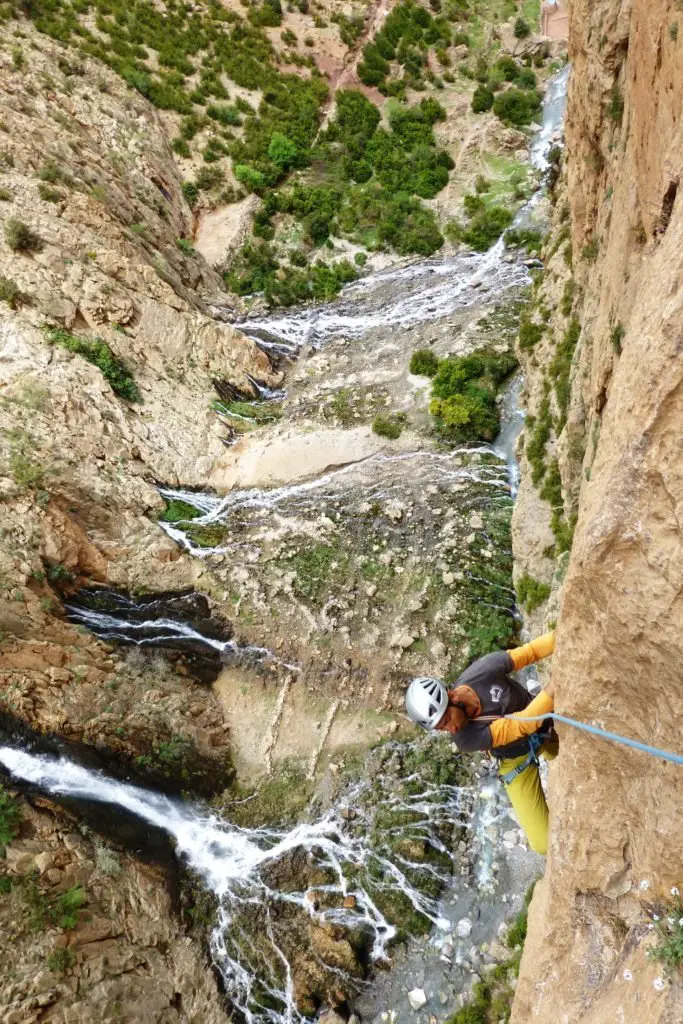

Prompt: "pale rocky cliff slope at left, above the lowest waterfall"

[0,23,274,782]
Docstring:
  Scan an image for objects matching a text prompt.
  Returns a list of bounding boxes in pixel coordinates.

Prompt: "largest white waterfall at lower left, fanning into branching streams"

[0,744,470,1024]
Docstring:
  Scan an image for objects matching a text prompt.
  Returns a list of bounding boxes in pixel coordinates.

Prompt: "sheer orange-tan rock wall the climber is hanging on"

[512,0,683,1024]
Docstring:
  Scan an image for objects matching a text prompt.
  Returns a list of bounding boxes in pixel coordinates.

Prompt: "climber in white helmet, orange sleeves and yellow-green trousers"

[405,633,558,855]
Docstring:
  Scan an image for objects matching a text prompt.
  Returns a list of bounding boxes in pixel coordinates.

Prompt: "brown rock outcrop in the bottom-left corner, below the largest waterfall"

[0,798,229,1024]
